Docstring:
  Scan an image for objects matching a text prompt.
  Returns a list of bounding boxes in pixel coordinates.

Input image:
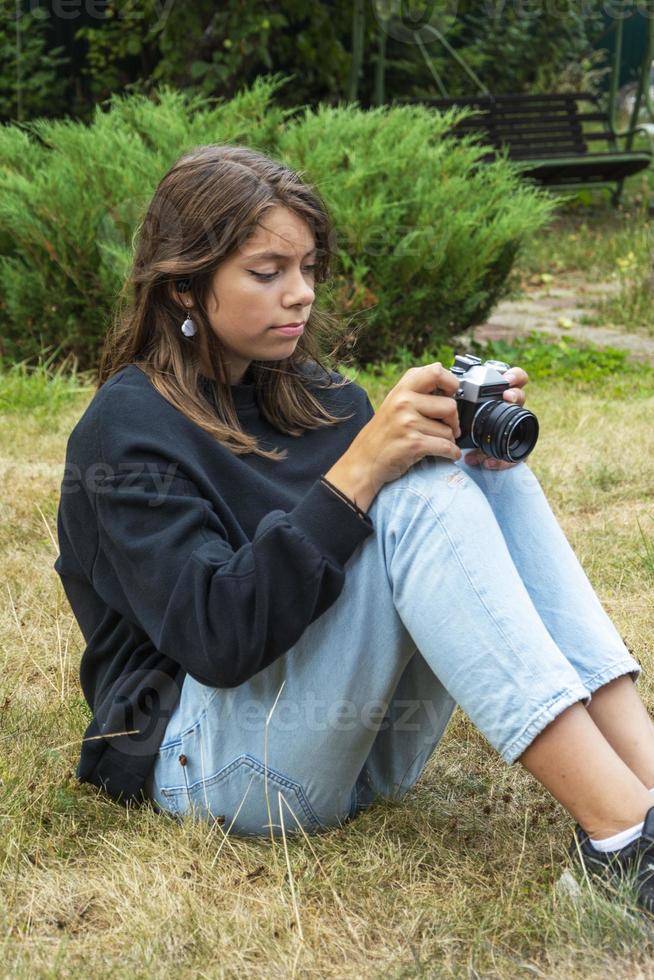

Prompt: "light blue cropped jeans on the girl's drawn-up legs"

[145,458,639,836]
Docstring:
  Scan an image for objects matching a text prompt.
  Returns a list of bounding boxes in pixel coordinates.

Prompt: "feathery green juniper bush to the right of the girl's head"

[279,106,553,364]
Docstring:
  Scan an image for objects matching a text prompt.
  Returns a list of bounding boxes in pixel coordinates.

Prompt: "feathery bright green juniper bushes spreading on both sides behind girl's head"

[0,76,552,370]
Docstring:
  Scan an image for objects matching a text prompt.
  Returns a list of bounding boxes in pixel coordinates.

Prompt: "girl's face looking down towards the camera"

[202,207,315,384]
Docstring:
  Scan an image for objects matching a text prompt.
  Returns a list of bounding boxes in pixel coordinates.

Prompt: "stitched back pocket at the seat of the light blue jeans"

[161,754,321,837]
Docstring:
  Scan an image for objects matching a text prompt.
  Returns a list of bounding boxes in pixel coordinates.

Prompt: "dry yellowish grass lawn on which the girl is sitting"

[0,370,654,978]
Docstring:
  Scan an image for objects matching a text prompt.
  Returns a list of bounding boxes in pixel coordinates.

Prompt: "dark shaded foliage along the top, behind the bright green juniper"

[0,0,608,121]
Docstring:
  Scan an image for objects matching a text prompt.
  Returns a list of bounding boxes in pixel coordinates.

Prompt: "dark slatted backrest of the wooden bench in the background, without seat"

[407,92,614,160]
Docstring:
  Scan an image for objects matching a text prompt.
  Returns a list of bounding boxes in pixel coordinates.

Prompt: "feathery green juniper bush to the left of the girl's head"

[0,79,288,369]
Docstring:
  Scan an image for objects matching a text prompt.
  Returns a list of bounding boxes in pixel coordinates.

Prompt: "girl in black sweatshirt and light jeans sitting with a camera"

[55,146,654,907]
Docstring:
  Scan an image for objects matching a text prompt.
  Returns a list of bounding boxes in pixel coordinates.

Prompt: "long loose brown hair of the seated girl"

[98,145,358,460]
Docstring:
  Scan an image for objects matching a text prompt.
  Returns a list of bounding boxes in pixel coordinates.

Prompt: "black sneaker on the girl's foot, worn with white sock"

[570,806,654,915]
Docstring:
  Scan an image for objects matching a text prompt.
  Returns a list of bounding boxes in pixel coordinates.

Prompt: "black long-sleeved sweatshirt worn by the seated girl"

[54,364,374,802]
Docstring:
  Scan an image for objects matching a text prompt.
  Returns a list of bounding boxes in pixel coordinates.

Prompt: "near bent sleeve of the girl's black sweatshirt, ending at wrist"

[92,467,373,687]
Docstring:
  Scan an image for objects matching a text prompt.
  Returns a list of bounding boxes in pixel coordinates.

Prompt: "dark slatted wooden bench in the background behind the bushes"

[402,92,652,204]
